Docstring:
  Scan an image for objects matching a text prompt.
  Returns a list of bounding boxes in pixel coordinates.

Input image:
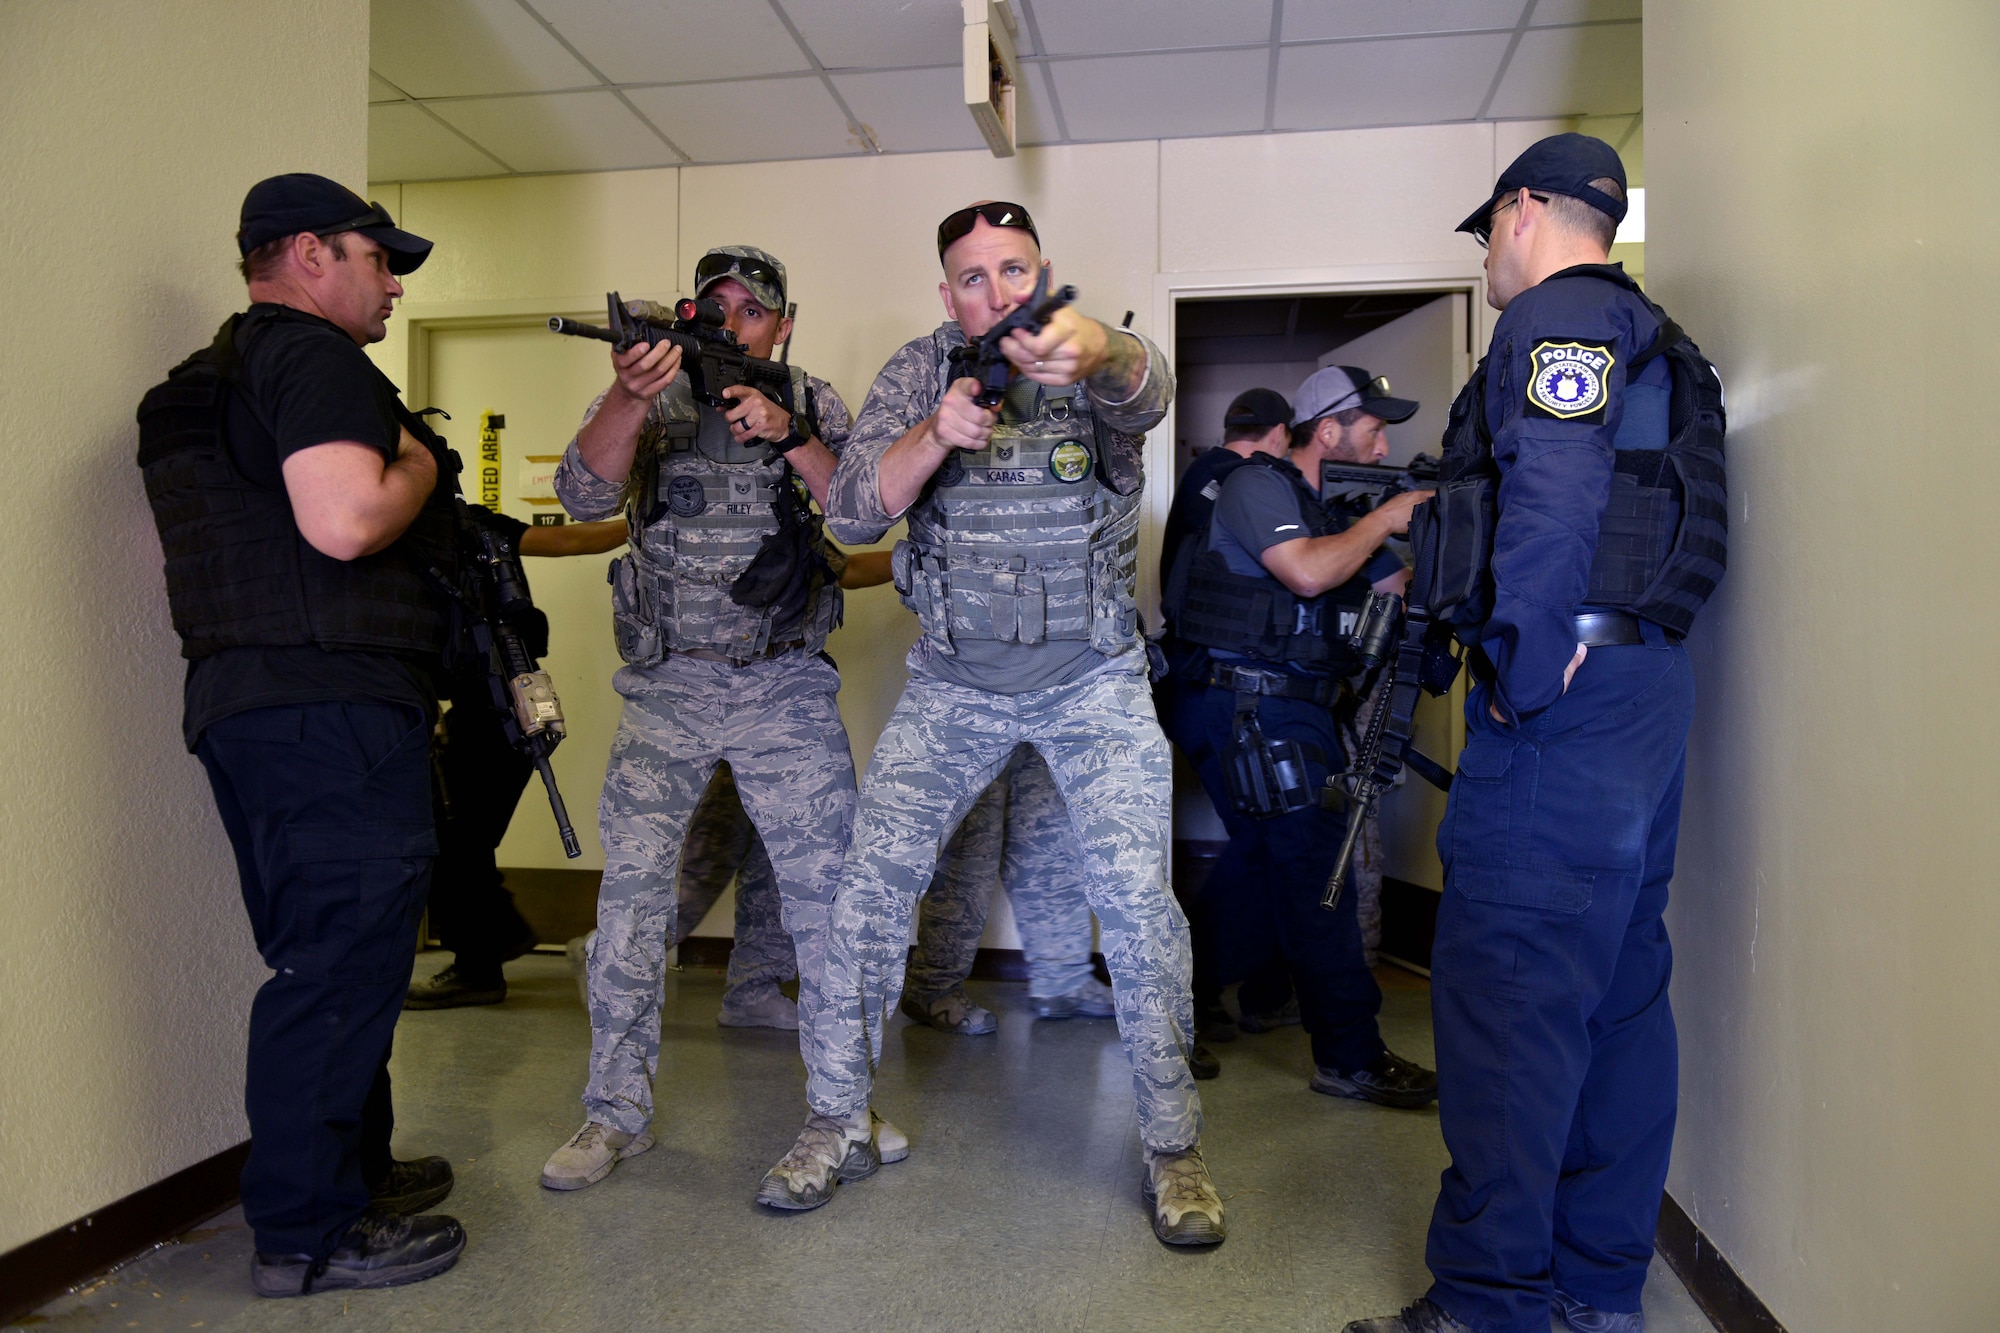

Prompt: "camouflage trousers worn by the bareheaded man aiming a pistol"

[802,652,1202,1153]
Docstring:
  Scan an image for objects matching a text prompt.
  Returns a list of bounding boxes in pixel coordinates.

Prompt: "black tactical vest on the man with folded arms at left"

[138,308,458,658]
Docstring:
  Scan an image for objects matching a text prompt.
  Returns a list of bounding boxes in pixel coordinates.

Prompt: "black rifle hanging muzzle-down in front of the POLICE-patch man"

[1320,588,1458,911]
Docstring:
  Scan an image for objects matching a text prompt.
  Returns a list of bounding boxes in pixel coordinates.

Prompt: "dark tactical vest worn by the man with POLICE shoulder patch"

[1410,268,1728,642]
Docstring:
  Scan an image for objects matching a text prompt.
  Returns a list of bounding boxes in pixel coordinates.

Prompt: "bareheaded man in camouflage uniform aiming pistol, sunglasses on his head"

[758,204,1224,1245]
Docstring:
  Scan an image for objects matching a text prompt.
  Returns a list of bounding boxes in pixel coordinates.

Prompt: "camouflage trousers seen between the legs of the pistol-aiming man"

[904,745,1092,1003]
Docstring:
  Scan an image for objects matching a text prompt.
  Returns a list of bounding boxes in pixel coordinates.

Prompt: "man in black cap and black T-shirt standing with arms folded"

[138,174,466,1297]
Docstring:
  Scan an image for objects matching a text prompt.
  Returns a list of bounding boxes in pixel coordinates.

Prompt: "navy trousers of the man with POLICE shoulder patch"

[1426,626,1694,1333]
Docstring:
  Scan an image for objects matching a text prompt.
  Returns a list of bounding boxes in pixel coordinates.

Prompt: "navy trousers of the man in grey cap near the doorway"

[1162,687,1382,1073]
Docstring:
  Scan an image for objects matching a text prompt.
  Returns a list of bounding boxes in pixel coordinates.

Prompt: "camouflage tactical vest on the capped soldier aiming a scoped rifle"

[608,366,842,667]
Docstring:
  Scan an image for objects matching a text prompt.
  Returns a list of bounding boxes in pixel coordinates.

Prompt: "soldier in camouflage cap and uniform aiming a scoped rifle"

[542,246,904,1189]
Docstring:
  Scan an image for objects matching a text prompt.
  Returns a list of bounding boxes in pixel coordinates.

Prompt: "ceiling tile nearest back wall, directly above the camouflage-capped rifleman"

[628,78,862,162]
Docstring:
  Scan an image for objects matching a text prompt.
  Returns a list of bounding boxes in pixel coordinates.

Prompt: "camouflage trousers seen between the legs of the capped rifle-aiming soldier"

[674,765,798,1001]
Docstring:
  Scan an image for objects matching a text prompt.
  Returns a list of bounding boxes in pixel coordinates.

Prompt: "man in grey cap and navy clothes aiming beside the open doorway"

[1162,366,1436,1107]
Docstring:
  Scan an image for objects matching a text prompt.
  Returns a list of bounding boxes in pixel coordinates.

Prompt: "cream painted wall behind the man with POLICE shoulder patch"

[1646,0,2000,1333]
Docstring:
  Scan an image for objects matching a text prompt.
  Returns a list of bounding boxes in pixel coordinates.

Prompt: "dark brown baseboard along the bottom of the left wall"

[0,1143,250,1323]
